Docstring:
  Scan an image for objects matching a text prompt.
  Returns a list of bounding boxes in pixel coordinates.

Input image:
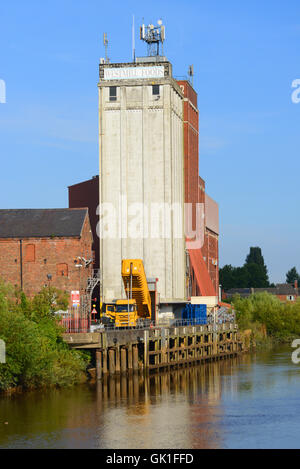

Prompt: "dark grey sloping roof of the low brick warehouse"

[0,208,88,238]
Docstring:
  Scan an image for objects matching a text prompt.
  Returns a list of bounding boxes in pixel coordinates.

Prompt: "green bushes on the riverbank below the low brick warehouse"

[0,282,88,390]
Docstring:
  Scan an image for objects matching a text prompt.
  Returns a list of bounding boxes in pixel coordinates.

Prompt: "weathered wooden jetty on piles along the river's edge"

[64,323,244,379]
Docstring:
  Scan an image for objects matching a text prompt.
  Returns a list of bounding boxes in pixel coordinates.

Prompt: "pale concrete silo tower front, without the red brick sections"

[98,57,186,303]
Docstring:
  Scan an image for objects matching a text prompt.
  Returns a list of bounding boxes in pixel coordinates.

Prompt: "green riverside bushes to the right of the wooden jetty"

[231,292,300,346]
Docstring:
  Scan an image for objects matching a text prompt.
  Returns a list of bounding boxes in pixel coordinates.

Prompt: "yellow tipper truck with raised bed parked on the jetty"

[106,259,151,327]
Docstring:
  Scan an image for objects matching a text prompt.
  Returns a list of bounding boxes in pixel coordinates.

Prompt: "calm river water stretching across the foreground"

[0,347,300,449]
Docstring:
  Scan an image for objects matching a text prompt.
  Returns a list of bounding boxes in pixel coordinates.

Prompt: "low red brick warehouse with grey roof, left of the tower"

[0,208,93,302]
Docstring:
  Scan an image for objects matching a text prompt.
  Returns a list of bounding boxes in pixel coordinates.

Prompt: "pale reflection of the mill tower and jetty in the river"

[96,362,227,448]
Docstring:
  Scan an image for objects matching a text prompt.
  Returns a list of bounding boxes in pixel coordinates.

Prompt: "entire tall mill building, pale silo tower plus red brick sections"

[69,57,219,310]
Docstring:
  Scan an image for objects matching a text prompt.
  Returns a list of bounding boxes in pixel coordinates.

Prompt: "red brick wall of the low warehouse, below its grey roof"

[0,217,92,302]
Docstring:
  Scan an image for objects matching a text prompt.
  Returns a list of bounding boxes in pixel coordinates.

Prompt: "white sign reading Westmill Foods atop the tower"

[104,66,165,80]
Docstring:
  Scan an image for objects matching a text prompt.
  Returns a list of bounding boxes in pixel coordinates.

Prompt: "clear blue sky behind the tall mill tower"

[0,0,300,282]
